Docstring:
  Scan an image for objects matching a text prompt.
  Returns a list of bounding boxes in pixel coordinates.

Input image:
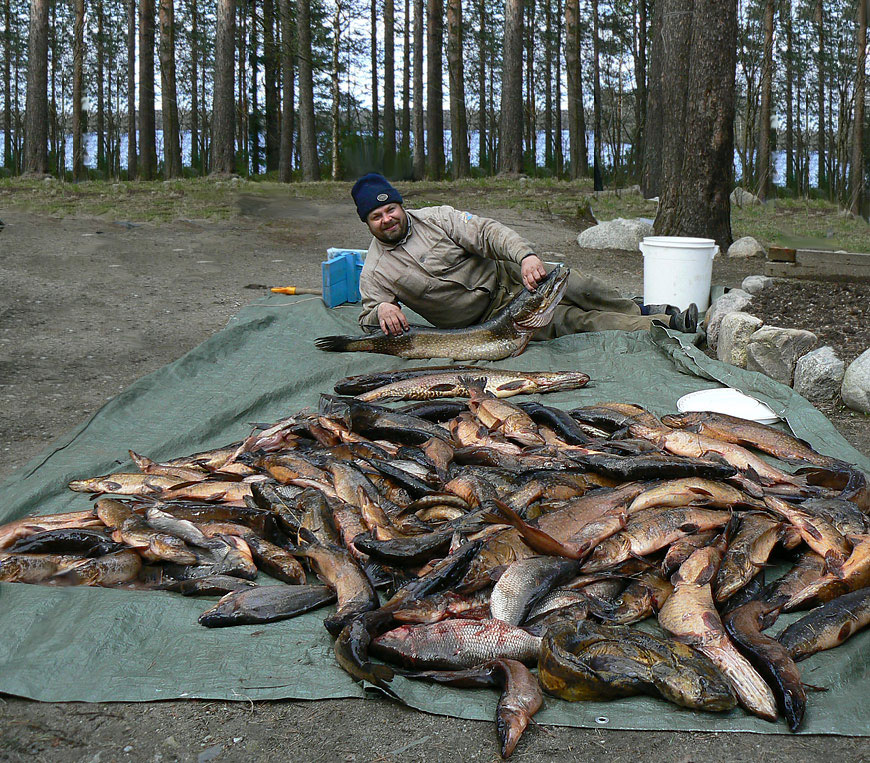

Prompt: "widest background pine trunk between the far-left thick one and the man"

[211,0,236,175]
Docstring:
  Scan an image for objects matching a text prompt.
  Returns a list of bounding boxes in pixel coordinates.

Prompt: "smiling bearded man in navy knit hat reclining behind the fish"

[351,173,698,340]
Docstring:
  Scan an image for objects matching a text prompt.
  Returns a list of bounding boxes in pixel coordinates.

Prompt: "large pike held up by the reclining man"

[314,266,570,360]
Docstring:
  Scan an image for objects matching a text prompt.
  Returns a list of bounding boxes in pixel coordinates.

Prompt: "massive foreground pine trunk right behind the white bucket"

[654,0,737,250]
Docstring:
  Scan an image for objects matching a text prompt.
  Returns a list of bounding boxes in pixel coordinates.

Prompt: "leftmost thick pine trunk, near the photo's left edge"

[23,0,49,175]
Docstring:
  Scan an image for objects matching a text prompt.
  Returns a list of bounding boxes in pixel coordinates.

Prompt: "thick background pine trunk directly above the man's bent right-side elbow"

[498,0,523,174]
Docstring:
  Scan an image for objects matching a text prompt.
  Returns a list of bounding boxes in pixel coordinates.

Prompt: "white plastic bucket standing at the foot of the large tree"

[640,236,719,314]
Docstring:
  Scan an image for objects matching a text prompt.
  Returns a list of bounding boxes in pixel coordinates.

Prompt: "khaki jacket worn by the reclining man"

[359,206,534,328]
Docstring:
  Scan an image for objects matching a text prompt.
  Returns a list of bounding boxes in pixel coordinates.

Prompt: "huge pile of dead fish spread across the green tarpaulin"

[0,366,870,756]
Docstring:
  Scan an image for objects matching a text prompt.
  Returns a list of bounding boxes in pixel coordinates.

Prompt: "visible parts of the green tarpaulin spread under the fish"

[0,296,870,735]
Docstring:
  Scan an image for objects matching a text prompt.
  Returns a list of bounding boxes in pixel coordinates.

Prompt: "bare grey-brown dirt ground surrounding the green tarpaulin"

[0,187,870,763]
